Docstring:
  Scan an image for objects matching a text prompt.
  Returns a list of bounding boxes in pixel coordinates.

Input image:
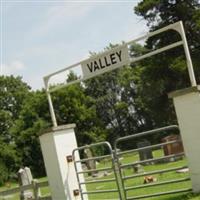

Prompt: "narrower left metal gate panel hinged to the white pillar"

[72,142,122,200]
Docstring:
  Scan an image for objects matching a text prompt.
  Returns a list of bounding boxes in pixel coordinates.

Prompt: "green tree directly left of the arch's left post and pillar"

[10,90,51,177]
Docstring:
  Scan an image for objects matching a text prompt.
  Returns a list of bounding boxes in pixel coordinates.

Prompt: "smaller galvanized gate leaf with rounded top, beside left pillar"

[72,142,122,200]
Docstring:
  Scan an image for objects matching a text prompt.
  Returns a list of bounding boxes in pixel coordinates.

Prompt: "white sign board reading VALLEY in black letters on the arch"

[81,45,130,78]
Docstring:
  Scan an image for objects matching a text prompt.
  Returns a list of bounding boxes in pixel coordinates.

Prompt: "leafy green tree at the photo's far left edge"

[0,76,30,184]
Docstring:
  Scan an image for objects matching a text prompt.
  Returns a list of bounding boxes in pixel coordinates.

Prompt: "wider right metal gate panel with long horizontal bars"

[115,125,192,200]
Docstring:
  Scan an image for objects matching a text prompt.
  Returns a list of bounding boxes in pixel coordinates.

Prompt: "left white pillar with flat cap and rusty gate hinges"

[40,124,87,200]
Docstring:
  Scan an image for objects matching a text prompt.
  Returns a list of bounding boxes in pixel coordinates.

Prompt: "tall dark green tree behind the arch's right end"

[135,0,200,127]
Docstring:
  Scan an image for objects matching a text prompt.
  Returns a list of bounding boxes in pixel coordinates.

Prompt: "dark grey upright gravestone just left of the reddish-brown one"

[137,140,153,164]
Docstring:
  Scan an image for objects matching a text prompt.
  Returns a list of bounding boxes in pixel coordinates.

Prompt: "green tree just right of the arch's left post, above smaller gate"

[52,84,106,145]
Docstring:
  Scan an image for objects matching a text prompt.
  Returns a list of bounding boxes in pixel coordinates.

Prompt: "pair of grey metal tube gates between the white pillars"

[73,125,192,200]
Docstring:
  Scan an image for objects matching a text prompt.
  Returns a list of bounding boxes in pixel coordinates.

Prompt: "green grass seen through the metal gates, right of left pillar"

[83,150,200,200]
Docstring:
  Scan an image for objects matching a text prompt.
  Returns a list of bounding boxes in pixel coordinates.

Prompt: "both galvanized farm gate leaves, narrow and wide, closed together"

[73,125,192,200]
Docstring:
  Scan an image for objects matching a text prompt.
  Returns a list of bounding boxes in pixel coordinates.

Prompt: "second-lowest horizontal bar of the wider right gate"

[125,177,191,191]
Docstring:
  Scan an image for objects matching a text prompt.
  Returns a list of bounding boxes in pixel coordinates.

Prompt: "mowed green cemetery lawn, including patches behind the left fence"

[0,150,200,200]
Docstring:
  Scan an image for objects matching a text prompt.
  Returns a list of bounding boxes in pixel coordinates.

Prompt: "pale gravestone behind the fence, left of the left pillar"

[17,167,34,200]
